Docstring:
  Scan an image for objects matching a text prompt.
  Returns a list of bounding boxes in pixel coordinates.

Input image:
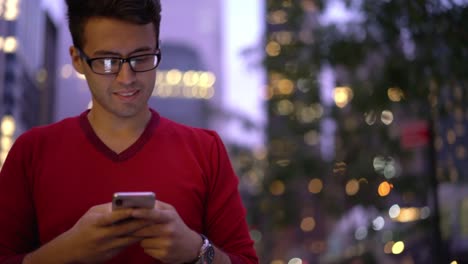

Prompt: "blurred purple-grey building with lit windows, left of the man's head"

[0,0,59,166]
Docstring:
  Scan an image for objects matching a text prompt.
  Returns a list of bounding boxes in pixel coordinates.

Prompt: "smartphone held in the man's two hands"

[112,192,156,210]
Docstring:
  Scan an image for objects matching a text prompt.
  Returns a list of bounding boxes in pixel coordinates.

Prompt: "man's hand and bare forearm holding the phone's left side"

[24,203,149,263]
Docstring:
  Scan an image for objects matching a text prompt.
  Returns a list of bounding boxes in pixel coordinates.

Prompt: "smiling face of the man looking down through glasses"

[70,18,157,118]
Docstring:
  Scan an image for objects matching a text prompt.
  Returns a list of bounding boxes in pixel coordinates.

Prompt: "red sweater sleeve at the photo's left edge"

[0,133,38,263]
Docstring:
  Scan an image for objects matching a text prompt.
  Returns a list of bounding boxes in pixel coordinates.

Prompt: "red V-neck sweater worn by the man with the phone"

[0,110,258,264]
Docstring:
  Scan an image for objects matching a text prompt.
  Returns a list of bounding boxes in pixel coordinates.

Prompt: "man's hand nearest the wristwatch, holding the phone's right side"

[132,201,203,263]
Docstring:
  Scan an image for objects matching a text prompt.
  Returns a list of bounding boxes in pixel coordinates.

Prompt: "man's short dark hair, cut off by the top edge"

[66,0,161,48]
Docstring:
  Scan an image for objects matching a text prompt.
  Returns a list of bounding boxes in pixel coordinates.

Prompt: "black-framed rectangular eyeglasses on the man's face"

[78,49,161,75]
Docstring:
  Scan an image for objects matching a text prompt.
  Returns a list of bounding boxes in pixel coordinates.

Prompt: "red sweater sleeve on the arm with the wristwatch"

[205,133,258,264]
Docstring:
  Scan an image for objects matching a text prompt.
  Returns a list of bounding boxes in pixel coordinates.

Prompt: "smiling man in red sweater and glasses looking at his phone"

[0,0,258,263]
